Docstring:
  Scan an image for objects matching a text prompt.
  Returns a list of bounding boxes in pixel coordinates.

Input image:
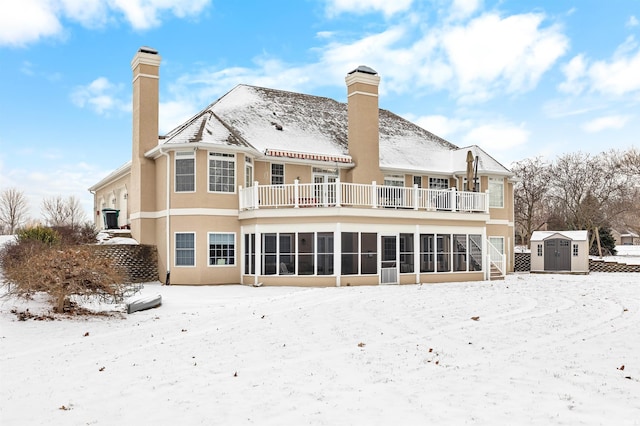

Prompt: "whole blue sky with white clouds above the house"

[0,0,640,218]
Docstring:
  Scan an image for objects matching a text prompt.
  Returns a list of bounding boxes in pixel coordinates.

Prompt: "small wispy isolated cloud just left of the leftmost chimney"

[71,77,131,115]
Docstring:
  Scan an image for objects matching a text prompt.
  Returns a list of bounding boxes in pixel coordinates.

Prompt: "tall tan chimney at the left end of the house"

[128,47,161,244]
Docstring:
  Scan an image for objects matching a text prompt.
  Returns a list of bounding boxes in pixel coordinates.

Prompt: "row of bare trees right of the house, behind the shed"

[511,148,640,253]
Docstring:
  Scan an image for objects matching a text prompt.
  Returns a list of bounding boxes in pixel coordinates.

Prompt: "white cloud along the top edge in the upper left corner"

[0,0,211,47]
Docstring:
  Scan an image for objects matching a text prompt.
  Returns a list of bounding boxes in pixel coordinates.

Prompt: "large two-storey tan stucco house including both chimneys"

[90,48,514,286]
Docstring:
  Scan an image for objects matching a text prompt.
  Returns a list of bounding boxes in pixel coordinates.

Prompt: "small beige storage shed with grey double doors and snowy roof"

[531,231,589,274]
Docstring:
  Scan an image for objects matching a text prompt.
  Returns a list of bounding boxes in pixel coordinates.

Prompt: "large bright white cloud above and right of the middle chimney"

[317,7,569,103]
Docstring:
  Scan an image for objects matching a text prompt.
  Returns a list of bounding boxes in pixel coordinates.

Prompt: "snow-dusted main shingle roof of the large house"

[160,84,510,174]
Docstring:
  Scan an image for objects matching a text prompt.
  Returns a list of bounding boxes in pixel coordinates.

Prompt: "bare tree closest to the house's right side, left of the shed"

[511,157,551,245]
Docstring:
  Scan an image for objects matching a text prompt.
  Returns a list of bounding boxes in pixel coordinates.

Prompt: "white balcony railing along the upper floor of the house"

[239,180,489,213]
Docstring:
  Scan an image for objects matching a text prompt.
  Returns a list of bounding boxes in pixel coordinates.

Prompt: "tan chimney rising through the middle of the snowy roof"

[345,65,383,184]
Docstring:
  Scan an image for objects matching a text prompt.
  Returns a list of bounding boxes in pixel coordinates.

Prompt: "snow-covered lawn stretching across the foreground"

[0,273,640,425]
